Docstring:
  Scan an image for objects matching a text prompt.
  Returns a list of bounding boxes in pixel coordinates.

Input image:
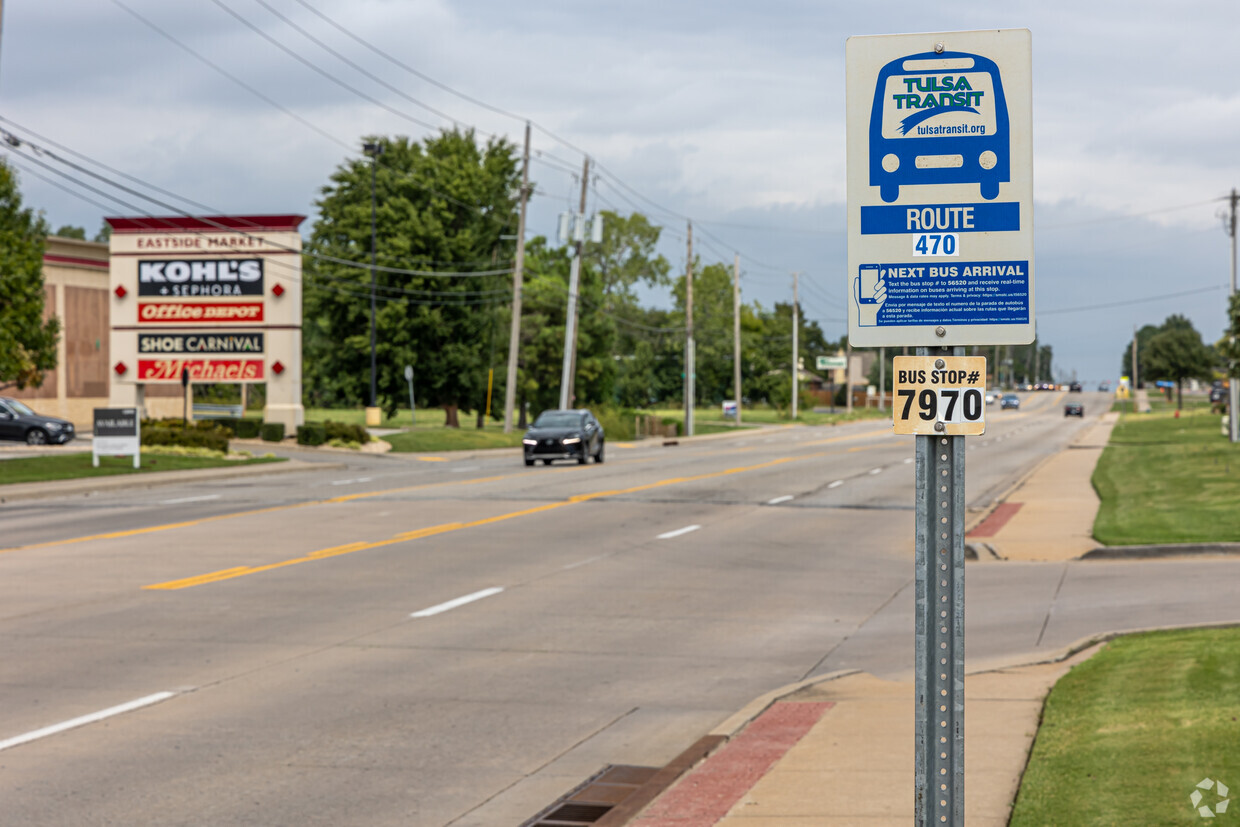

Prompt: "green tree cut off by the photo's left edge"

[0,160,61,389]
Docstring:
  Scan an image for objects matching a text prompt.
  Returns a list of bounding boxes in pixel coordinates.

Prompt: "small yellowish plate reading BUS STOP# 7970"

[892,356,986,436]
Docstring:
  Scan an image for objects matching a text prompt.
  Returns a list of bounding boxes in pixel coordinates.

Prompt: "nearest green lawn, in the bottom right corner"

[1009,629,1240,827]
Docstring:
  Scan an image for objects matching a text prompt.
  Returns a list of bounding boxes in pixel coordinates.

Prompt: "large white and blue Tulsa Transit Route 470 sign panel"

[846,29,1034,347]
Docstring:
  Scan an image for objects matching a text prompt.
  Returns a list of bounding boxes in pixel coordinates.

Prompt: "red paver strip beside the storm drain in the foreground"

[636,702,835,827]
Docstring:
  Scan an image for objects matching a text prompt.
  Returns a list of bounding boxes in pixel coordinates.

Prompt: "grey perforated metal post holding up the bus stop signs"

[914,347,965,827]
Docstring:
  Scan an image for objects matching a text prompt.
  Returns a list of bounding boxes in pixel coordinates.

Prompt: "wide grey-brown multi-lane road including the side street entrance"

[0,393,1236,827]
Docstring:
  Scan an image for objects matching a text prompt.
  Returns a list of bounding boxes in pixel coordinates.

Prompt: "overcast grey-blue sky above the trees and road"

[0,0,1240,382]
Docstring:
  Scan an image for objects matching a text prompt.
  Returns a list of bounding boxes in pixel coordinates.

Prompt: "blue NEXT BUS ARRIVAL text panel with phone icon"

[853,262,1029,327]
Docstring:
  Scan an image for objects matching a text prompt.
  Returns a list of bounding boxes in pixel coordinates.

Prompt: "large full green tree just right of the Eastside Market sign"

[303,130,520,427]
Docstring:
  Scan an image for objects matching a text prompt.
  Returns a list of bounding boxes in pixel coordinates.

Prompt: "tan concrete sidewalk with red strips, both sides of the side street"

[629,414,1118,827]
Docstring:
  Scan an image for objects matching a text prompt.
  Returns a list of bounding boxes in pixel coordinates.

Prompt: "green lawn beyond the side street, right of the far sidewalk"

[1092,407,1240,546]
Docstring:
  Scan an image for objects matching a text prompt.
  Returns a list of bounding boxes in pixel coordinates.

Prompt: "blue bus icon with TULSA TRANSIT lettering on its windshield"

[869,52,1012,203]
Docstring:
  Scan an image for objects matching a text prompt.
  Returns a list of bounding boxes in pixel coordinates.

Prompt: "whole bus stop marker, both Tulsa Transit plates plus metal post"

[844,29,1034,827]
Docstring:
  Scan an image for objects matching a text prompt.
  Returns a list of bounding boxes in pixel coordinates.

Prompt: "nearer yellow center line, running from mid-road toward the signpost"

[143,453,826,590]
